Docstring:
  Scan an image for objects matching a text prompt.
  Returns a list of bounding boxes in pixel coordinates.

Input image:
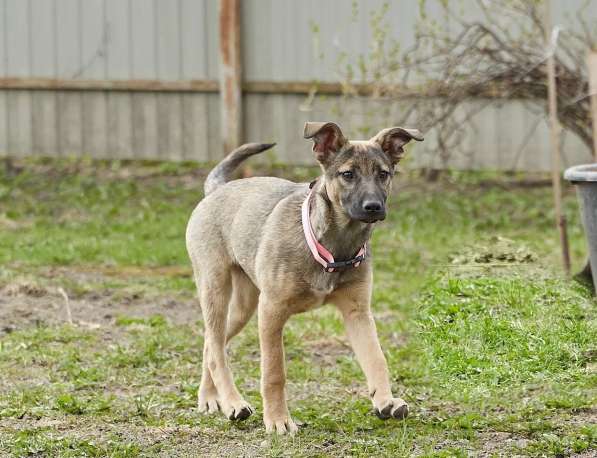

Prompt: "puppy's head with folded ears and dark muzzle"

[305,122,423,223]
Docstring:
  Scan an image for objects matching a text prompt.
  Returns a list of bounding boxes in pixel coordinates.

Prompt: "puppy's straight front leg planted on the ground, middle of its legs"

[258,294,298,434]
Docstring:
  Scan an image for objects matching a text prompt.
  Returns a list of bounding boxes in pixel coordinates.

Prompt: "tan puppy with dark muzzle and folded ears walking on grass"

[186,122,423,434]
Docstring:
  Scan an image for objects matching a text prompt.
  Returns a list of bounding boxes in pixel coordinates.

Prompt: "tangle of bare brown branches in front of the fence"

[332,0,597,165]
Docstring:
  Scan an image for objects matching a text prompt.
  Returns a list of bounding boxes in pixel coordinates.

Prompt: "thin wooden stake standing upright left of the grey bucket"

[545,0,570,275]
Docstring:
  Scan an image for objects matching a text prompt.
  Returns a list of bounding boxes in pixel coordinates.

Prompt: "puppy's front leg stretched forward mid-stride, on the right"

[334,291,408,420]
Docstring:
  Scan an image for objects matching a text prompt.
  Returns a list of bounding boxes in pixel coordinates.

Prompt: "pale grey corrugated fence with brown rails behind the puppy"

[0,0,597,170]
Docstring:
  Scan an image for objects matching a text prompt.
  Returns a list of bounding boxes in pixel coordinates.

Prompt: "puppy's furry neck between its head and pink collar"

[311,180,373,261]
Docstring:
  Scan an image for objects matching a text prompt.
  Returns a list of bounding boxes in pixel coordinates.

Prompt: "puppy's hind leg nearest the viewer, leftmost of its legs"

[199,264,253,420]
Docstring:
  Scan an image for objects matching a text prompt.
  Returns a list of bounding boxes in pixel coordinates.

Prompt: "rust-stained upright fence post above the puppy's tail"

[219,0,243,153]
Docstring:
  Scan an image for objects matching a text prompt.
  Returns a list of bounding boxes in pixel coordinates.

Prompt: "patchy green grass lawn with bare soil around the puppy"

[0,161,597,457]
